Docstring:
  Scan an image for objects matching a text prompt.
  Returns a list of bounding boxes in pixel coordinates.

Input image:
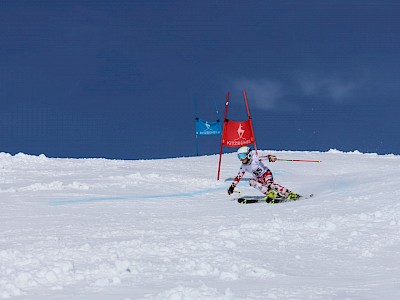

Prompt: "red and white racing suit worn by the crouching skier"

[232,151,290,197]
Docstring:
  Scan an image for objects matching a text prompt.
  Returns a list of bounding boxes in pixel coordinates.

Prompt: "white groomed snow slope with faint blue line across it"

[0,150,400,300]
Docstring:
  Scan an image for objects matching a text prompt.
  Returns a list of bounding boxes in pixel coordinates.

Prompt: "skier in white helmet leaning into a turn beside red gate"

[228,146,300,203]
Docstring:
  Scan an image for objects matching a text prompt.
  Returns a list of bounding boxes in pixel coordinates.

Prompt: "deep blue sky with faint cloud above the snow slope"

[0,0,400,159]
